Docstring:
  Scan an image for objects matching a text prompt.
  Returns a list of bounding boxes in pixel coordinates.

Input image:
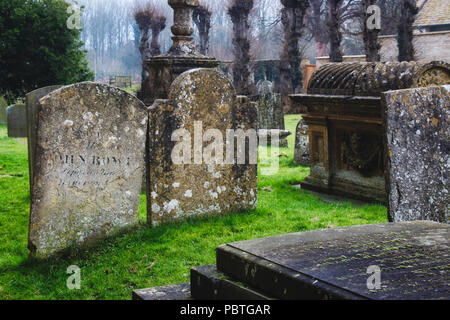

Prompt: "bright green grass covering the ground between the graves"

[0,115,387,300]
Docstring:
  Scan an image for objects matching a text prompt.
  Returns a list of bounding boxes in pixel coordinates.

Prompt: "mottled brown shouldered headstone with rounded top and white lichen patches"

[147,69,257,225]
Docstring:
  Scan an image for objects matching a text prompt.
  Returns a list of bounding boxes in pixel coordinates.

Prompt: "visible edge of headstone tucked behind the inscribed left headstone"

[25,86,61,188]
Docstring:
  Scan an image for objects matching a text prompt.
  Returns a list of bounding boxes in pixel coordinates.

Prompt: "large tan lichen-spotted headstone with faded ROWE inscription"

[29,82,148,258]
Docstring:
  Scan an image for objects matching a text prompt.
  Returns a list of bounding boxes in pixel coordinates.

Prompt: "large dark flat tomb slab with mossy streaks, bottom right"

[217,221,450,300]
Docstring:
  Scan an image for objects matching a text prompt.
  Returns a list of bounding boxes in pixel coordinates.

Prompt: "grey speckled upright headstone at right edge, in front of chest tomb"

[382,85,450,223]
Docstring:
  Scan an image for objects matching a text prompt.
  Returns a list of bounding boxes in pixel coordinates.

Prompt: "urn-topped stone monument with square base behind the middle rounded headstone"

[139,0,219,104]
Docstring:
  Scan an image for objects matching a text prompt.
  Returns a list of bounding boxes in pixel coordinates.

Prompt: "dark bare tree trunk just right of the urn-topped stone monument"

[228,0,254,95]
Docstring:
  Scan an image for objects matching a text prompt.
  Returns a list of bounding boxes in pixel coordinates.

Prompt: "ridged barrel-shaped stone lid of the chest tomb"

[308,61,450,96]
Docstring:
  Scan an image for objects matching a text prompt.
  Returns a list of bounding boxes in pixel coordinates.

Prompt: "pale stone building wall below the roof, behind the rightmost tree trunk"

[379,31,450,63]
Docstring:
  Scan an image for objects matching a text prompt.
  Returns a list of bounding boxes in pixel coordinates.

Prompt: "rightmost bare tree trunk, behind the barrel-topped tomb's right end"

[397,0,419,61]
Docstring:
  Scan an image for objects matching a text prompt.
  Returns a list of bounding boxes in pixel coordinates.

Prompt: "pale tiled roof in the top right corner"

[414,0,450,26]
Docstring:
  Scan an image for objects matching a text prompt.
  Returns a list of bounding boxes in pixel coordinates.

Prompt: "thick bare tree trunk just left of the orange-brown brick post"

[280,0,309,96]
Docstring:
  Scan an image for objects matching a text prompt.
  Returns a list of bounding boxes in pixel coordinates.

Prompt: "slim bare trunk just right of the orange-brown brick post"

[327,0,342,62]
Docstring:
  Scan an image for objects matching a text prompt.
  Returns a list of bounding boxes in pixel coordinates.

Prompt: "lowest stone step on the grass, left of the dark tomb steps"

[133,283,192,300]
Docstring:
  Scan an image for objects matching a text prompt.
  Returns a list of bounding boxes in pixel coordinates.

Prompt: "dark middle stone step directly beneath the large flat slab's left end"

[191,265,270,300]
